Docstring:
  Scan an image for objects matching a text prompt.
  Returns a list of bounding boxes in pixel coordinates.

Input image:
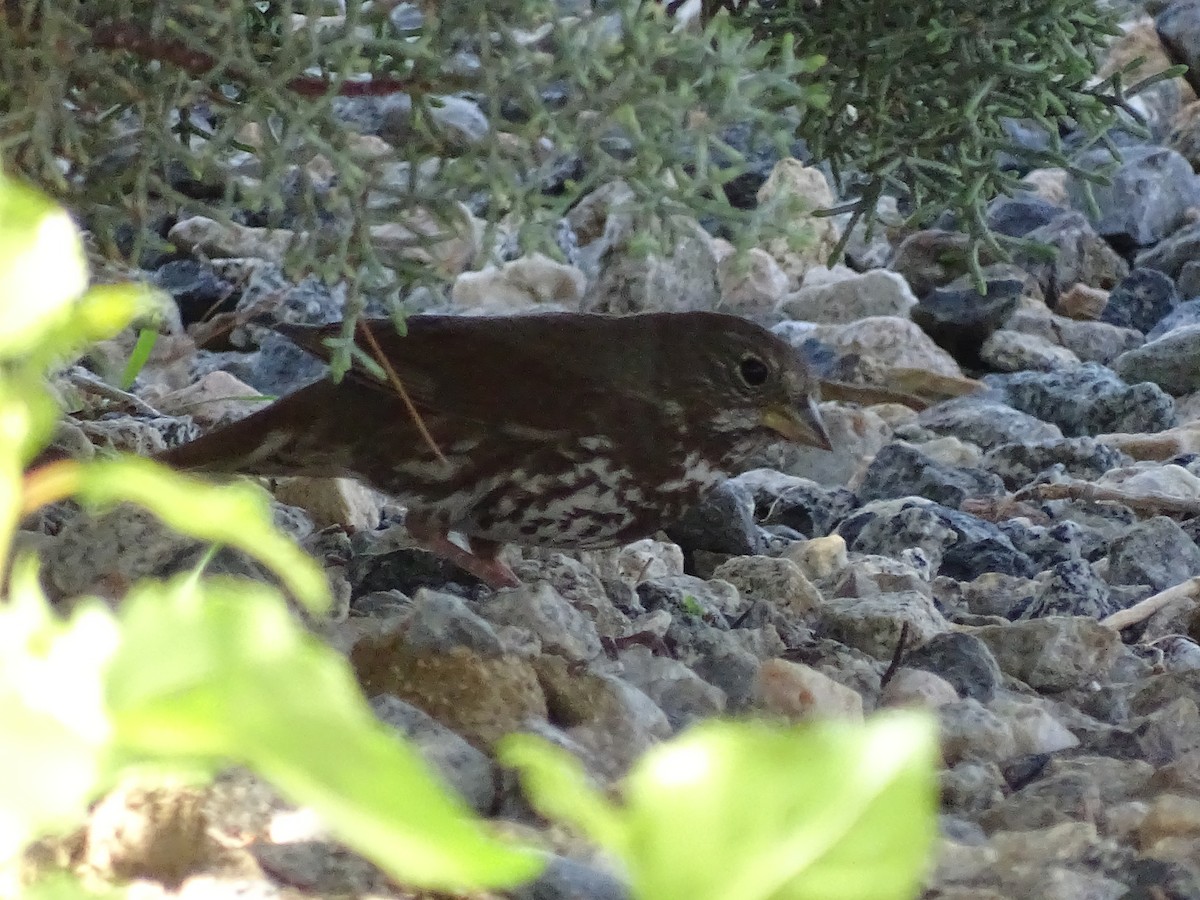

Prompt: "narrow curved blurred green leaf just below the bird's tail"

[72,456,329,612]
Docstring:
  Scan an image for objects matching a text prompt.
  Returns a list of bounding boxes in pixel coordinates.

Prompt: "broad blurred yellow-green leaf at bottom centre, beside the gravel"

[505,715,936,900]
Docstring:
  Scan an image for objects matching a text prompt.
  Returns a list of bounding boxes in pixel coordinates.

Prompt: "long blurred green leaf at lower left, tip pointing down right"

[108,578,540,889]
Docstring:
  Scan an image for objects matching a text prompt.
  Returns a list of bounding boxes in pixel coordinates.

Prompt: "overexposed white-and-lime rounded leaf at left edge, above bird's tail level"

[0,173,88,359]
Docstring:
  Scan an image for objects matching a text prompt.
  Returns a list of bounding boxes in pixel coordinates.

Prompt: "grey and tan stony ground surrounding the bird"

[22,6,1200,900]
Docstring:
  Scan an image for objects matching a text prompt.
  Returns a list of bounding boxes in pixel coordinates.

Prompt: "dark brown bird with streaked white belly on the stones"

[158,312,829,587]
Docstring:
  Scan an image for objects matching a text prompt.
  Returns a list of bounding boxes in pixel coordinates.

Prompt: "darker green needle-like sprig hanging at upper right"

[739,0,1161,265]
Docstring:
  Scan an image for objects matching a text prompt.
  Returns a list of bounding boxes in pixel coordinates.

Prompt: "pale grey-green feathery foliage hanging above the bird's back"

[0,0,821,289]
